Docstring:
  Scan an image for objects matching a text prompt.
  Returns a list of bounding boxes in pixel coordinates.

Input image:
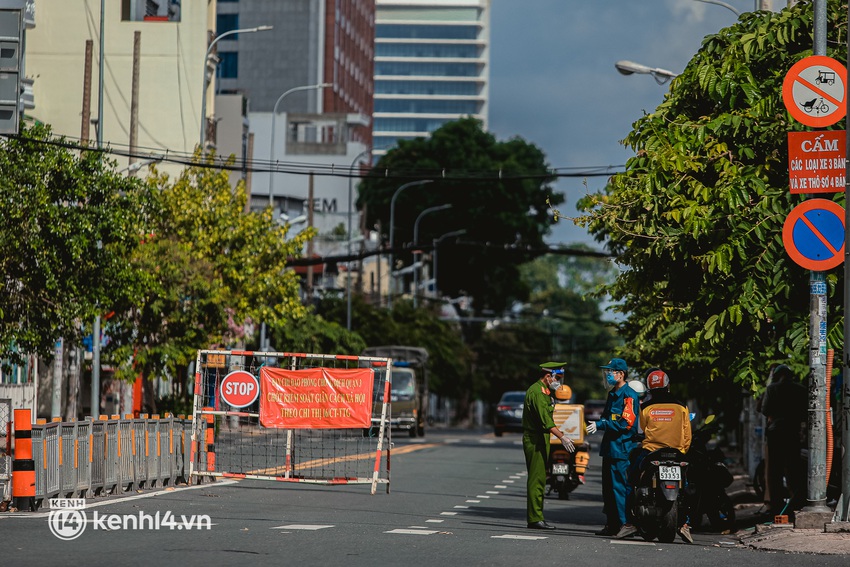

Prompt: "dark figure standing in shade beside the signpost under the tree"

[761,364,808,515]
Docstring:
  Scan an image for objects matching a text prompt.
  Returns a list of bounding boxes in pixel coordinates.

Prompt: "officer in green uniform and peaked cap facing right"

[522,362,576,530]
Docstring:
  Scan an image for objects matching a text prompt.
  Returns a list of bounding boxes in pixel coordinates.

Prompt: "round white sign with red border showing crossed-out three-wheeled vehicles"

[782,55,847,128]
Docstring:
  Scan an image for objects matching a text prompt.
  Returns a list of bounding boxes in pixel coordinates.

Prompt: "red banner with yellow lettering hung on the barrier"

[260,367,374,429]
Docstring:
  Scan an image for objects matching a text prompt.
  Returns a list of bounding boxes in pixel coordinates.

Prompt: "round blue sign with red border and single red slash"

[782,199,844,272]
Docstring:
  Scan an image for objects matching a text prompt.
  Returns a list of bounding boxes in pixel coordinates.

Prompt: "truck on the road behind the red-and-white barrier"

[363,345,429,437]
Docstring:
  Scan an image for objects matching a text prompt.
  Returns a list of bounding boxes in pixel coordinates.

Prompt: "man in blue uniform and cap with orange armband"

[587,358,640,537]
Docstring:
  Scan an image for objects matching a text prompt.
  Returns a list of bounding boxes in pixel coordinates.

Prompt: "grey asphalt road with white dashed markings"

[0,429,847,567]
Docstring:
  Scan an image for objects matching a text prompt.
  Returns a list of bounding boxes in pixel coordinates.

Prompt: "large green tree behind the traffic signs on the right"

[582,4,846,393]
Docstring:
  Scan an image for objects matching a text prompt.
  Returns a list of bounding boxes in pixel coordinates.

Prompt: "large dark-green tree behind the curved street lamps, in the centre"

[358,118,564,313]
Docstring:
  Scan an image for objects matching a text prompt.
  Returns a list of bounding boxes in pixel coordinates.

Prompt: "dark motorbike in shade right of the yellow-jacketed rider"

[685,415,735,533]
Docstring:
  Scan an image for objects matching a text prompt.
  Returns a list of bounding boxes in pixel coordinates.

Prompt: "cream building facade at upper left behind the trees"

[26,0,215,178]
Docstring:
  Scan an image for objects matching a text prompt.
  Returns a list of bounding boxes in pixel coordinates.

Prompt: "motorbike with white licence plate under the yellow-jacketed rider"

[632,448,688,543]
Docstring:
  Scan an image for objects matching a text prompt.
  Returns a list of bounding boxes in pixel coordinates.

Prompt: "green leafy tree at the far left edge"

[0,125,144,360]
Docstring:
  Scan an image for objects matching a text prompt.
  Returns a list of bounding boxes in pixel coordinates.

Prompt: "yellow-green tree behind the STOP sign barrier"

[109,160,314,404]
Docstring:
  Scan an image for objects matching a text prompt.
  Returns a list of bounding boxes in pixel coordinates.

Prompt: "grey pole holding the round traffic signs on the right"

[795,0,831,528]
